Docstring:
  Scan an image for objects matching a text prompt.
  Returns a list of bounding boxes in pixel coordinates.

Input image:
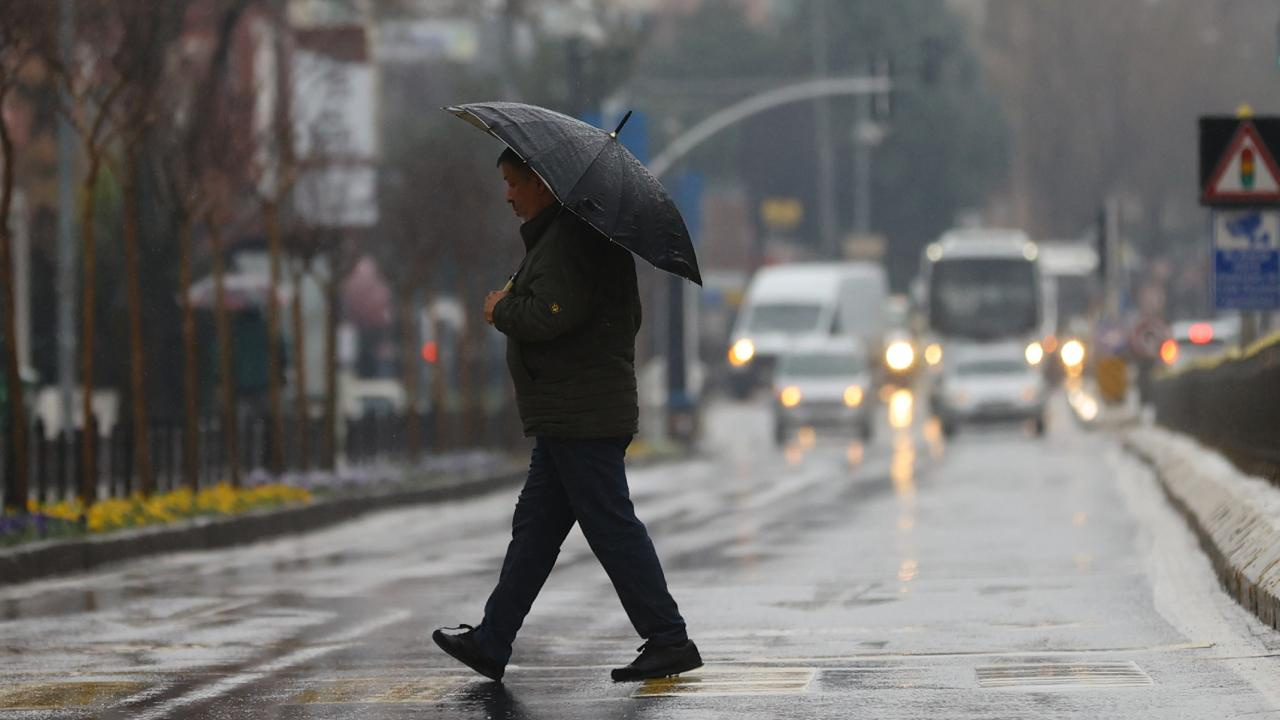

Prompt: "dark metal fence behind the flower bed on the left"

[0,406,522,502]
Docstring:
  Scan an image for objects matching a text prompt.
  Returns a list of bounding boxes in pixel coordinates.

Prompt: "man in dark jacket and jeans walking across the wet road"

[431,149,703,682]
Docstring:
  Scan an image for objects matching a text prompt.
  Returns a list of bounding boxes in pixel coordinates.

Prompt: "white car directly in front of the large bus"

[929,343,1046,437]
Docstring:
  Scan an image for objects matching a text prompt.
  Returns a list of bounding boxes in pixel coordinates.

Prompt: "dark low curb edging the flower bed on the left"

[0,468,526,585]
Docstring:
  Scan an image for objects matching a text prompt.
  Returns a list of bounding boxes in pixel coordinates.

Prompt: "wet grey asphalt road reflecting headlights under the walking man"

[0,393,1280,720]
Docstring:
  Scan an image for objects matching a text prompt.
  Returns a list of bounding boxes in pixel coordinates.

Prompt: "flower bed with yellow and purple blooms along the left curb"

[0,483,312,546]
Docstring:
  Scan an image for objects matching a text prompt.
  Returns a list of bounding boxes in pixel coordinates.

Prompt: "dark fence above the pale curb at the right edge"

[1152,334,1280,486]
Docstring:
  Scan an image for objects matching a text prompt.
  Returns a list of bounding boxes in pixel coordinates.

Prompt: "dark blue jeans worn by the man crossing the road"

[475,437,689,664]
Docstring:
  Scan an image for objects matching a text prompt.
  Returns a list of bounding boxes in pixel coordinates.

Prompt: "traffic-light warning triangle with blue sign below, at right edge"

[1199,110,1280,346]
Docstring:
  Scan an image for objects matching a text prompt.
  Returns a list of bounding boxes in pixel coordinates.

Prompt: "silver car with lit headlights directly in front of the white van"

[773,341,876,446]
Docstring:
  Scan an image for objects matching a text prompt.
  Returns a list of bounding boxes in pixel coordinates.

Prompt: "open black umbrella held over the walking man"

[445,102,703,284]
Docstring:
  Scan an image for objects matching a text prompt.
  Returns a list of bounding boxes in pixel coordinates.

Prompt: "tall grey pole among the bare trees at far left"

[58,0,76,432]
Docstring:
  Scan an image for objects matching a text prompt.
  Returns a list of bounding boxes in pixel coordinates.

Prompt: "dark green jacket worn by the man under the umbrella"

[493,204,640,438]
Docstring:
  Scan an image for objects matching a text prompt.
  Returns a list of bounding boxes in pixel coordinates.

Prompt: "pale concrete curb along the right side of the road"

[1124,428,1280,630]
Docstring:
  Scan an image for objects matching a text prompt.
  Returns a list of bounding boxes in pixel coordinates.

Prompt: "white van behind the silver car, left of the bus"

[728,263,888,396]
